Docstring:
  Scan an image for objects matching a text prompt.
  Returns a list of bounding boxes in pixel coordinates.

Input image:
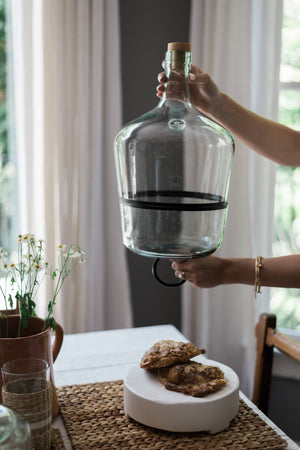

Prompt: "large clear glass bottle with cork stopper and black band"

[115,43,234,259]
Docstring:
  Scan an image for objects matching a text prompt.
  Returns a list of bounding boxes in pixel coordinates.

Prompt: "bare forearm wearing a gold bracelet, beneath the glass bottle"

[224,255,300,288]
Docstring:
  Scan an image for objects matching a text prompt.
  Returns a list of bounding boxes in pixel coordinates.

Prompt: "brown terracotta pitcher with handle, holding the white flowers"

[0,315,64,418]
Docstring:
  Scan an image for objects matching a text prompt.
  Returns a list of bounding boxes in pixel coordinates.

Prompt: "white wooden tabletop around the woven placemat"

[53,325,300,450]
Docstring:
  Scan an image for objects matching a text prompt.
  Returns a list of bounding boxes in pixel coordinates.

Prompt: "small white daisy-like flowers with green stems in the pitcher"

[0,234,85,337]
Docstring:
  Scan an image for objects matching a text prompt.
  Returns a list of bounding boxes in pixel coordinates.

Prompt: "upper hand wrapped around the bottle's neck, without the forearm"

[157,65,221,116]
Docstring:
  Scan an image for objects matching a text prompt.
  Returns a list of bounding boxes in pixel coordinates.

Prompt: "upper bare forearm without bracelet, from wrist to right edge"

[212,94,300,166]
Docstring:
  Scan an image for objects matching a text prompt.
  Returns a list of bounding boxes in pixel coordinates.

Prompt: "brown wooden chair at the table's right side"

[252,314,300,414]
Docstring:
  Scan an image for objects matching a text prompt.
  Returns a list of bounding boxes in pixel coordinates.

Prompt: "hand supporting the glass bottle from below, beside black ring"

[172,255,229,288]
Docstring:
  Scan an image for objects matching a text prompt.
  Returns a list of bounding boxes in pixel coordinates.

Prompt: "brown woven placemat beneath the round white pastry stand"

[57,380,287,450]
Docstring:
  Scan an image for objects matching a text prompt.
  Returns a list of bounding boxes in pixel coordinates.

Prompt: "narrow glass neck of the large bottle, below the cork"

[162,50,192,103]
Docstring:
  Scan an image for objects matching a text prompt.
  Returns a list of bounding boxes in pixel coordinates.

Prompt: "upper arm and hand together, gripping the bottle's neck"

[157,61,300,167]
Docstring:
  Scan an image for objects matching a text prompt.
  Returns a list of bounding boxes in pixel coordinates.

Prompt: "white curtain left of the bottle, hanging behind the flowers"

[11,0,131,332]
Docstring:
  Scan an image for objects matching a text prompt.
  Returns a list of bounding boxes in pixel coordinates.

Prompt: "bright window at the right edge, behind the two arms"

[270,0,300,332]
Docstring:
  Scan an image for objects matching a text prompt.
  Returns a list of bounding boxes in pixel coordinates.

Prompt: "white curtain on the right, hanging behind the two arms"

[188,0,283,395]
